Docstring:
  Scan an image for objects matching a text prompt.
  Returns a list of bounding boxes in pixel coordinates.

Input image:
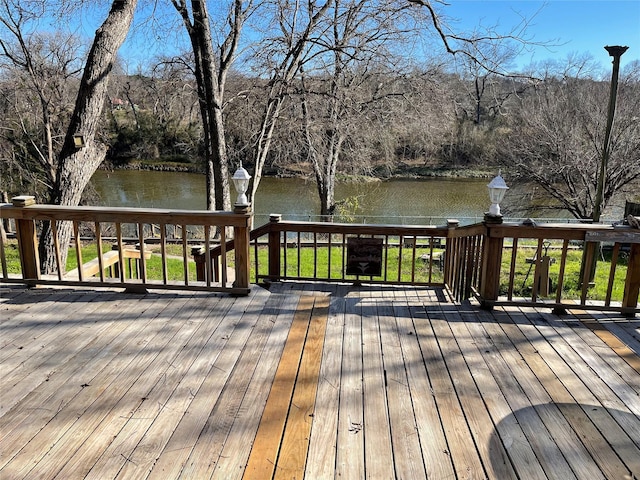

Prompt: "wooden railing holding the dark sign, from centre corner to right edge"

[196,215,640,313]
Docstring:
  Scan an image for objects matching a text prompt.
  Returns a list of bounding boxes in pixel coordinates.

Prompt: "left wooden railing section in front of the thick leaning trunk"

[0,197,252,294]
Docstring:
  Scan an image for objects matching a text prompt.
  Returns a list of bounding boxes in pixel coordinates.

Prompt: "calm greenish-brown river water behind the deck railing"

[93,170,511,225]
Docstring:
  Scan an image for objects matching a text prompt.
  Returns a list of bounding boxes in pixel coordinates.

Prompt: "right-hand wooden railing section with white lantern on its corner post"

[458,222,640,314]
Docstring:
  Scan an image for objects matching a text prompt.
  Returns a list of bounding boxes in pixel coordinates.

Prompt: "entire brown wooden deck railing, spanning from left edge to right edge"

[0,199,640,314]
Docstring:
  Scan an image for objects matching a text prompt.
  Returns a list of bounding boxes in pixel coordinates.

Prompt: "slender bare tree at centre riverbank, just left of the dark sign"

[300,0,420,216]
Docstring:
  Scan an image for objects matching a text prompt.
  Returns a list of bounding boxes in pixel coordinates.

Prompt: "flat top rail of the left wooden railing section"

[0,204,251,227]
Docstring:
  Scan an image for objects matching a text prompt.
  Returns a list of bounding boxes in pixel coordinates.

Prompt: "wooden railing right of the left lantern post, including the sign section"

[190,216,640,313]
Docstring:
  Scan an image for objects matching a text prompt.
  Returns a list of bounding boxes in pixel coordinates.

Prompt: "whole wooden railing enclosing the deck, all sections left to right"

[0,195,640,314]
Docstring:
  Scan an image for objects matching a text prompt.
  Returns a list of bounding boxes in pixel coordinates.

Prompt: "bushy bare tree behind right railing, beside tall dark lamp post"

[500,60,640,220]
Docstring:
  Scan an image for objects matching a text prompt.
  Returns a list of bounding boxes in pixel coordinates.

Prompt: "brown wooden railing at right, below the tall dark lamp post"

[462,222,640,315]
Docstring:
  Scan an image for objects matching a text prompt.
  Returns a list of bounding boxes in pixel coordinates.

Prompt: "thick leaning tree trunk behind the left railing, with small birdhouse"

[40,0,137,273]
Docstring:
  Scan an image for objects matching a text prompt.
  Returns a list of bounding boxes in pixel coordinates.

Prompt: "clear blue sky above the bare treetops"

[51,0,640,71]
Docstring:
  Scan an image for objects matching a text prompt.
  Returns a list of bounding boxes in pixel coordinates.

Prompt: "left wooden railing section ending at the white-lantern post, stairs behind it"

[0,197,251,294]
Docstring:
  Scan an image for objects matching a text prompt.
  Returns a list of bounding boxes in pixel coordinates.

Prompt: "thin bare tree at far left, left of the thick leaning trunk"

[0,0,82,197]
